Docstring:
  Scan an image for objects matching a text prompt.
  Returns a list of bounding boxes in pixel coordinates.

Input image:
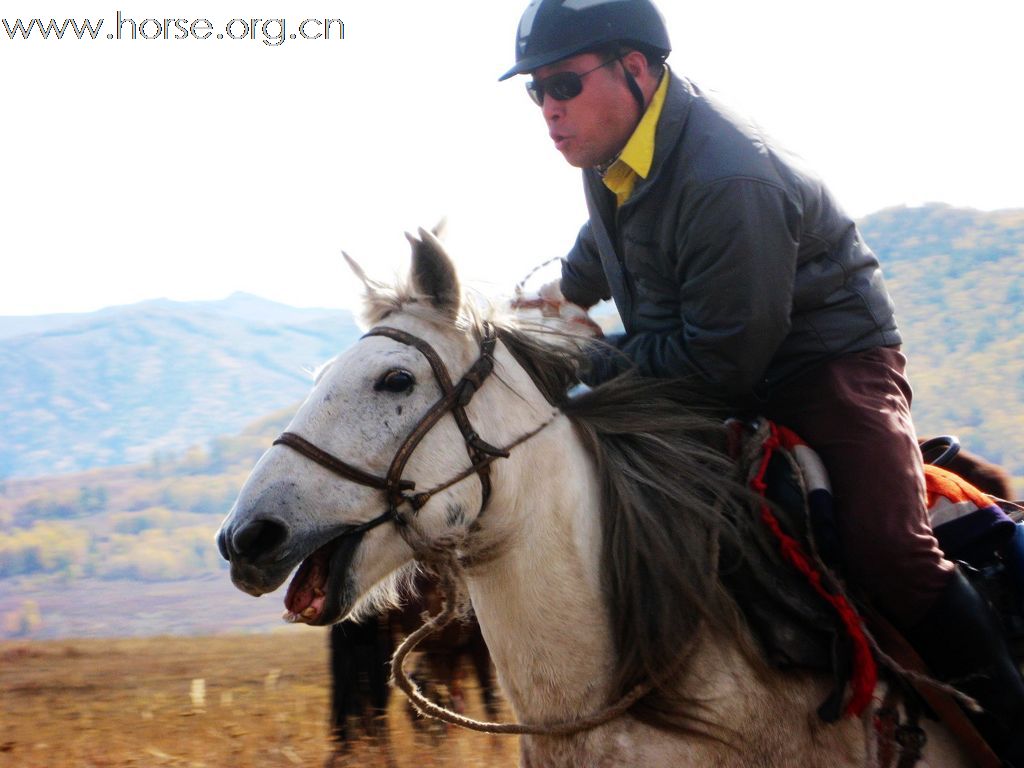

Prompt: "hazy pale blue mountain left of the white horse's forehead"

[0,294,358,478]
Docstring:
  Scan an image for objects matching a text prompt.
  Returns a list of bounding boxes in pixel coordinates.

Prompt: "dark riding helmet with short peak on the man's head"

[498,0,672,80]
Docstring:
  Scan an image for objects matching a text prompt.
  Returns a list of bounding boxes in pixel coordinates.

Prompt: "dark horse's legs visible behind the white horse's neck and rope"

[331,574,498,750]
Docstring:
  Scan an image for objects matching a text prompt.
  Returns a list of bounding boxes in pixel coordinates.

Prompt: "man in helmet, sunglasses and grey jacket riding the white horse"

[501,0,1024,766]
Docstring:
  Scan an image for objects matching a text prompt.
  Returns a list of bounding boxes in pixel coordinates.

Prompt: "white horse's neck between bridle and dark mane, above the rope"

[467,417,612,722]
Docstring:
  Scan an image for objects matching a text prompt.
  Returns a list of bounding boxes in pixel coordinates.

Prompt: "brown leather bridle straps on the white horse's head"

[273,323,557,536]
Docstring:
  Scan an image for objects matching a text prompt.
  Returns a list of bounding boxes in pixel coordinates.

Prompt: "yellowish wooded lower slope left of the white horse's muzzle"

[0,411,298,638]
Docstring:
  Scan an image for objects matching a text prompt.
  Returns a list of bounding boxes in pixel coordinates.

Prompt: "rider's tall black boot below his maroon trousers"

[906,570,1024,768]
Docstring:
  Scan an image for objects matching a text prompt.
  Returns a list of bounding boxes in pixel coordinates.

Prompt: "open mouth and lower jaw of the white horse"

[282,534,362,627]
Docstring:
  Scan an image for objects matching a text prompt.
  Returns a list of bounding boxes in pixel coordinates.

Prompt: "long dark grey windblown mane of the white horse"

[489,324,763,737]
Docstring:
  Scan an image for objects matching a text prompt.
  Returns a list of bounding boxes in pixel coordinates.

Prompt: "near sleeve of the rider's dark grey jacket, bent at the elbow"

[595,178,800,395]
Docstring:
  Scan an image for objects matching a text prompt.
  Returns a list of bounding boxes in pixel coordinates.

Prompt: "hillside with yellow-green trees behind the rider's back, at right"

[861,205,1024,481]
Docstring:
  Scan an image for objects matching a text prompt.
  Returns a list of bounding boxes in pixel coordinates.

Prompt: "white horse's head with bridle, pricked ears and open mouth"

[211,229,551,625]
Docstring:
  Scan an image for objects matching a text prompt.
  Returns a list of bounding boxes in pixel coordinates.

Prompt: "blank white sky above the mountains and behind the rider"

[0,0,1024,314]
